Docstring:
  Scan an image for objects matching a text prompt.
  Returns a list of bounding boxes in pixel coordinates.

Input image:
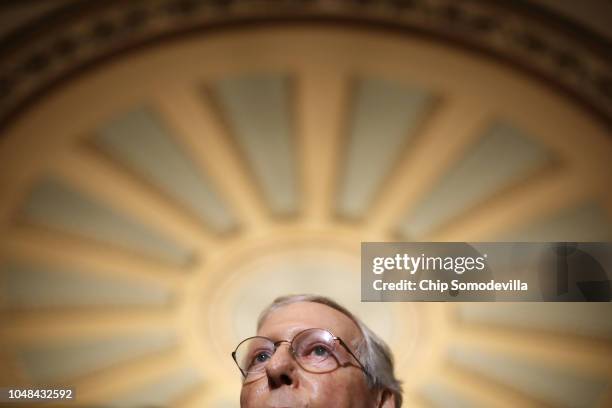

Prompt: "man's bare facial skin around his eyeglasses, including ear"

[240,302,395,408]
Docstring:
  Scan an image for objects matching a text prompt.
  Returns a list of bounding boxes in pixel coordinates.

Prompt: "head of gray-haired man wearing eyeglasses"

[234,295,402,408]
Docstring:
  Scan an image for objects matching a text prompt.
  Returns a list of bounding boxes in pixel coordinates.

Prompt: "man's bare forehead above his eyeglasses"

[257,302,361,342]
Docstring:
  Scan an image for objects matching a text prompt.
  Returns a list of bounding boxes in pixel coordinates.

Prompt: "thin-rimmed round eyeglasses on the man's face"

[232,329,365,378]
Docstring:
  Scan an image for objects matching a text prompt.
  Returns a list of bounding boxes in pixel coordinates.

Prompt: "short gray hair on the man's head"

[257,295,402,408]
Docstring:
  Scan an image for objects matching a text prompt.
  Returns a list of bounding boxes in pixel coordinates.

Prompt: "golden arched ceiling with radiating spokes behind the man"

[0,1,612,407]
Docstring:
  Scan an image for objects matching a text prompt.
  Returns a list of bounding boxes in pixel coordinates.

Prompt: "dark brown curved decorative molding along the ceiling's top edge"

[0,0,612,128]
